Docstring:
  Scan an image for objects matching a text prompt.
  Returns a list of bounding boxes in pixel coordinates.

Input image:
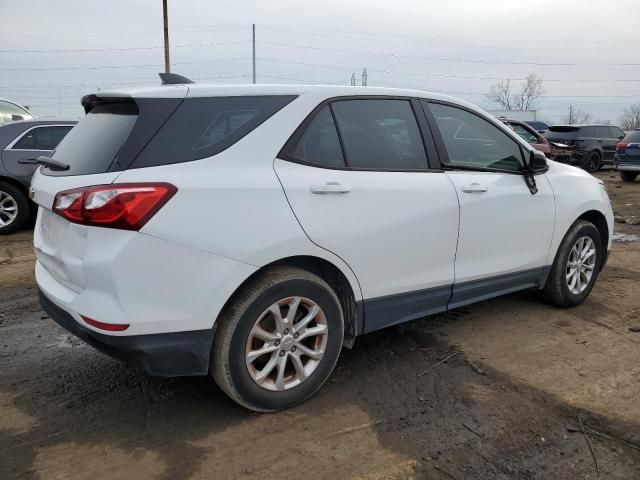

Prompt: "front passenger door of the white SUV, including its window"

[425,102,555,307]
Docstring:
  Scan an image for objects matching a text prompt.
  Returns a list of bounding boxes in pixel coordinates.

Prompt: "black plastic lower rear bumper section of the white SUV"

[38,290,214,377]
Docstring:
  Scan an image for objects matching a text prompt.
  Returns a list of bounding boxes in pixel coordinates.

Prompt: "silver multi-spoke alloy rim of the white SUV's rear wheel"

[245,297,329,391]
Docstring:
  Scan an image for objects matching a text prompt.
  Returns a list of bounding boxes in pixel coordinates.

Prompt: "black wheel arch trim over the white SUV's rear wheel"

[216,255,363,348]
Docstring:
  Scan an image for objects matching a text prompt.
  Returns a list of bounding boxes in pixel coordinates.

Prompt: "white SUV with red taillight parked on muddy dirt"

[32,80,613,411]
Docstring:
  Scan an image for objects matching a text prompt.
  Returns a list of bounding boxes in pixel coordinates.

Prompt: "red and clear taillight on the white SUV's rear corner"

[53,183,178,230]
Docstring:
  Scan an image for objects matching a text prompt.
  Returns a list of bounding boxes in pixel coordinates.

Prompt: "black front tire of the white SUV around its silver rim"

[543,220,604,307]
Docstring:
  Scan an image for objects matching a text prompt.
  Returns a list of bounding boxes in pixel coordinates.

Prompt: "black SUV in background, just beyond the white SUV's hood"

[544,125,624,172]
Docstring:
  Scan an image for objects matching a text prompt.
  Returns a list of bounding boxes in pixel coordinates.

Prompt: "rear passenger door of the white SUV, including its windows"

[274,97,458,331]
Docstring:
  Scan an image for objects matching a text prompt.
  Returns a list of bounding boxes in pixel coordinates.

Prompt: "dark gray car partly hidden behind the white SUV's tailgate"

[0,120,77,235]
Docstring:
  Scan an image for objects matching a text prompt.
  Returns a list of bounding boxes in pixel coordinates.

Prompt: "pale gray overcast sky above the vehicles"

[0,0,640,123]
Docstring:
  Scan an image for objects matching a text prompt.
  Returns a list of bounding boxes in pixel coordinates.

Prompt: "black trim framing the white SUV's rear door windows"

[276,95,443,173]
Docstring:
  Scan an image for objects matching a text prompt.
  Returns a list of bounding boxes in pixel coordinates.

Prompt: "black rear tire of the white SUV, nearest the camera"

[210,266,344,412]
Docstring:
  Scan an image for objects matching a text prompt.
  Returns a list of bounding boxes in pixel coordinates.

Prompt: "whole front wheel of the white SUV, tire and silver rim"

[543,220,604,307]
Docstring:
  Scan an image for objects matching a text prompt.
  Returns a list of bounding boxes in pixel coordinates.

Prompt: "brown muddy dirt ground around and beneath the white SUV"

[0,172,640,480]
